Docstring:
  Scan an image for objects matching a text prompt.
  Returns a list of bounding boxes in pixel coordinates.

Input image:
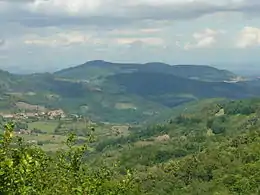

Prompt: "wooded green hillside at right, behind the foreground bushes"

[88,99,260,195]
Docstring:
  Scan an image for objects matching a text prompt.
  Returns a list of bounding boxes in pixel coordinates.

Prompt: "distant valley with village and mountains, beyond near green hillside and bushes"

[0,61,260,153]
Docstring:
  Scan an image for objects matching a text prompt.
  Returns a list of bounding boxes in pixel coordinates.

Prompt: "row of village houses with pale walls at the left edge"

[0,109,66,119]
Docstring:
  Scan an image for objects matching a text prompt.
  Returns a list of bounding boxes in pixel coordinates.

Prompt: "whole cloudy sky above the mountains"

[0,0,260,71]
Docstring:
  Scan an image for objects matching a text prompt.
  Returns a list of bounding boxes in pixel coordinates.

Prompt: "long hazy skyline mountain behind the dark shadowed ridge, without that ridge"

[54,60,237,82]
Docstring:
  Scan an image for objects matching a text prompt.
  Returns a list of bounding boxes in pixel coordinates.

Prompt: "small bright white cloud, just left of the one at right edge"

[184,28,225,50]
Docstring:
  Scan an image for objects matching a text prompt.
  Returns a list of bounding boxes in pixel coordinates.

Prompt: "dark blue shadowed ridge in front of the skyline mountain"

[108,72,258,107]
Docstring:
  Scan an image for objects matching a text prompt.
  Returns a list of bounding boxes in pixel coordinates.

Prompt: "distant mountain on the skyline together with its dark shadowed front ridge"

[51,60,259,121]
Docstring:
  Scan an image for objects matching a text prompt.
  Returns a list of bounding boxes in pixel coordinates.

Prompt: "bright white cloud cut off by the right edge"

[236,26,260,48]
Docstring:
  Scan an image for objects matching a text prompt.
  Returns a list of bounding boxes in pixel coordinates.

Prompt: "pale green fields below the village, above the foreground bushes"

[14,120,129,151]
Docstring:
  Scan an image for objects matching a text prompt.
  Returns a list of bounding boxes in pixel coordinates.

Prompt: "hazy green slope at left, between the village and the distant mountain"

[0,73,168,123]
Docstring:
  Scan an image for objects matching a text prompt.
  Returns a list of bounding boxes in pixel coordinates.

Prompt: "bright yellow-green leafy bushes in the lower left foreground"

[0,124,141,195]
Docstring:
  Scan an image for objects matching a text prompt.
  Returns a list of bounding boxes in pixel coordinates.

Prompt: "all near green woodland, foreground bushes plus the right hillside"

[0,99,260,195]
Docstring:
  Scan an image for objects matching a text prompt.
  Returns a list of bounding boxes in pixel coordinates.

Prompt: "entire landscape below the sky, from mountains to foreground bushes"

[0,61,260,195]
